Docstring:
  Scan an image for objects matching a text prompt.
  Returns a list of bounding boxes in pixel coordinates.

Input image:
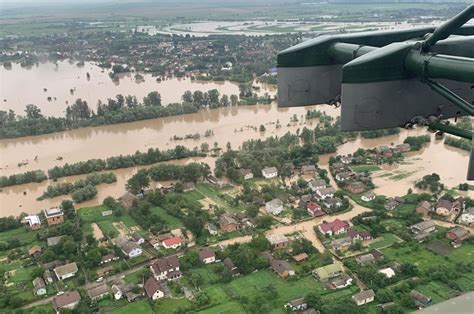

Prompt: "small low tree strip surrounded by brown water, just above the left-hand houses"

[38,172,117,200]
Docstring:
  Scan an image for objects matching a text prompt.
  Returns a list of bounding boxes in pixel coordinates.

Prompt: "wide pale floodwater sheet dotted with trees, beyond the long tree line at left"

[0,61,276,117]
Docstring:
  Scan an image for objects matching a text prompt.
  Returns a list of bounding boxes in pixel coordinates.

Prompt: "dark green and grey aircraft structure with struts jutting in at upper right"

[278,5,474,180]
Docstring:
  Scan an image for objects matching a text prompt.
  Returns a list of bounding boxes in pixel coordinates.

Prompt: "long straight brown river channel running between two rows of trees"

[0,104,340,175]
